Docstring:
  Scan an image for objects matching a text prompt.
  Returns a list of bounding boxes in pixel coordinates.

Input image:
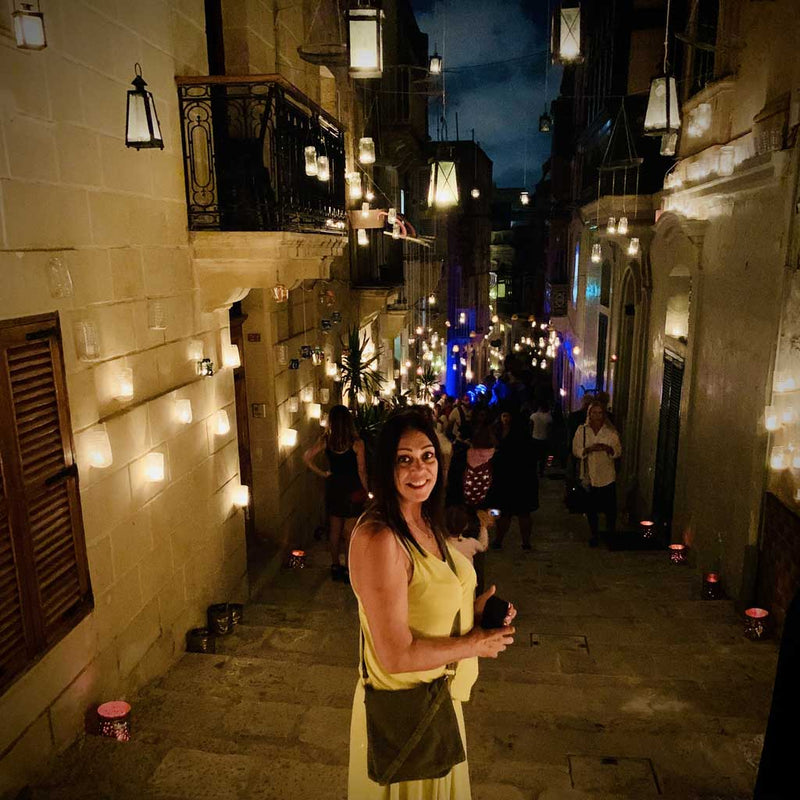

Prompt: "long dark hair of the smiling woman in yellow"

[368,408,447,555]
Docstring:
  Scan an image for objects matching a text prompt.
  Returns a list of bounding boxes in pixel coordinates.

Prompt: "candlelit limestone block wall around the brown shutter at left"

[0,0,246,792]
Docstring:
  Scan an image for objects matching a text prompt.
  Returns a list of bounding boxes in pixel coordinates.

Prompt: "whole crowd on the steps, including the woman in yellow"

[304,366,622,800]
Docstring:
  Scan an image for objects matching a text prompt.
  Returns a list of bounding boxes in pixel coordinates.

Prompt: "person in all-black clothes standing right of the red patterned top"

[487,410,539,550]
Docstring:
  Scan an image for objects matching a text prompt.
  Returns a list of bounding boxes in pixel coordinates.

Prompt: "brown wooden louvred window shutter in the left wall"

[0,314,92,690]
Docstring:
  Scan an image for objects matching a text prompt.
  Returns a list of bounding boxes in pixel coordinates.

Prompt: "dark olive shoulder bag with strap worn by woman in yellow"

[361,547,467,786]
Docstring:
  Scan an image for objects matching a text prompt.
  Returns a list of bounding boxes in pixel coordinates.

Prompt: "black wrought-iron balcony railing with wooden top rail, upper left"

[177,75,345,233]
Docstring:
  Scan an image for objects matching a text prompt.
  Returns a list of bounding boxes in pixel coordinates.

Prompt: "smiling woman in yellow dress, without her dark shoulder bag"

[348,410,516,800]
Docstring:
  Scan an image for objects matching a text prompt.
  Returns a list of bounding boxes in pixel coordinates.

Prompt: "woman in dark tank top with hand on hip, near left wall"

[303,405,368,583]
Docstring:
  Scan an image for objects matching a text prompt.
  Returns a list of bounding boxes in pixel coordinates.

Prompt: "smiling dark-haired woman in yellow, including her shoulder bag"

[348,410,515,800]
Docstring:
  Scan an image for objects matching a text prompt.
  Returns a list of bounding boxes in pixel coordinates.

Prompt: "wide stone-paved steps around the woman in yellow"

[23,472,776,800]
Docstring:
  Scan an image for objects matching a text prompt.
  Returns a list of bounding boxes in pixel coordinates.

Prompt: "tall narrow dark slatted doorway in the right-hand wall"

[653,350,685,541]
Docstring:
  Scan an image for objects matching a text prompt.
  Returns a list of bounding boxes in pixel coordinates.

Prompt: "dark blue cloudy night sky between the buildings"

[412,0,561,189]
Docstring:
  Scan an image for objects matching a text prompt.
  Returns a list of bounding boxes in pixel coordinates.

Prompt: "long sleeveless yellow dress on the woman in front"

[347,545,478,800]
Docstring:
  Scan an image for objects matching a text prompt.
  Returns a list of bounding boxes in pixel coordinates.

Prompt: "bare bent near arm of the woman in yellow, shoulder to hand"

[350,525,514,673]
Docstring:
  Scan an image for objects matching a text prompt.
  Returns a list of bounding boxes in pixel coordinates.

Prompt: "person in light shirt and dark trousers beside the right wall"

[572,400,622,547]
